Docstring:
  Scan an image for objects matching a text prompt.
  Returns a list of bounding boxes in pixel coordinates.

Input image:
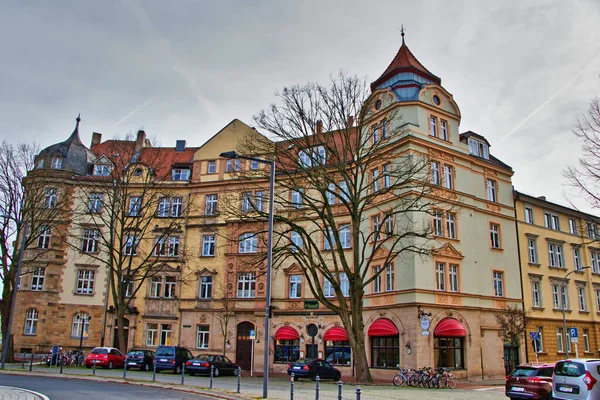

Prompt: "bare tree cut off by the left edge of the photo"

[0,141,67,362]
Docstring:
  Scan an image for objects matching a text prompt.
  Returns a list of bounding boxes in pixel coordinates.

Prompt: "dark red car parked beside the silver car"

[504,363,554,400]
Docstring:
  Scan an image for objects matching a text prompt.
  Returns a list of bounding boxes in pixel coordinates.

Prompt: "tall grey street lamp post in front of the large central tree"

[220,151,275,399]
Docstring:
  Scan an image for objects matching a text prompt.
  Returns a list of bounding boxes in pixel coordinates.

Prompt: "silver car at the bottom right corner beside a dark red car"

[552,358,600,400]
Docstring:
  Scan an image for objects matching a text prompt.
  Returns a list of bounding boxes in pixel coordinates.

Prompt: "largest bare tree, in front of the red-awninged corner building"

[229,73,443,382]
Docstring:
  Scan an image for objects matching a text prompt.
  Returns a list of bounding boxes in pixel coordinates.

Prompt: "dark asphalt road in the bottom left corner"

[0,374,214,400]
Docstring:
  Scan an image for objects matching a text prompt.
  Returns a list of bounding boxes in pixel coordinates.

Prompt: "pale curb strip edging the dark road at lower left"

[0,369,255,400]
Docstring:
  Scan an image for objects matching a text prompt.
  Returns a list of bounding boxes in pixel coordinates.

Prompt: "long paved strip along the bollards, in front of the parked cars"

[0,365,506,400]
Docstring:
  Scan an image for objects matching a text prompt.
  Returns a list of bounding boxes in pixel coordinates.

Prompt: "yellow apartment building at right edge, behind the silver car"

[514,191,600,362]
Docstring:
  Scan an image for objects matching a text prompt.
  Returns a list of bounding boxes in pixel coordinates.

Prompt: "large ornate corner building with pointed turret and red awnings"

[13,41,524,380]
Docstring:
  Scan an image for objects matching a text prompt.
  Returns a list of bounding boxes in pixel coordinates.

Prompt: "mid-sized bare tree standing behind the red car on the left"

[66,140,192,350]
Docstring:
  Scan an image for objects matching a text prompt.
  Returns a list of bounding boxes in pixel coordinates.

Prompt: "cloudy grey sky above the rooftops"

[0,0,600,210]
